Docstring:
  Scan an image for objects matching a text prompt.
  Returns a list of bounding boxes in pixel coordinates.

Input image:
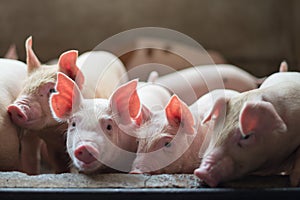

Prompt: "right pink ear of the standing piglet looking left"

[58,50,84,89]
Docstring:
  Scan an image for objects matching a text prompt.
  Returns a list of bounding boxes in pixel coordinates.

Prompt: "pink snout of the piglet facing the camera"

[74,145,99,164]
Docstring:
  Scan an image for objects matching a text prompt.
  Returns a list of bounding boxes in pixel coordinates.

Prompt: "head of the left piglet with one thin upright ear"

[8,37,83,130]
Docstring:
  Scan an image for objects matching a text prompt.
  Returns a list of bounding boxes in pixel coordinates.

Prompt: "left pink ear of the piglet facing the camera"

[50,72,82,121]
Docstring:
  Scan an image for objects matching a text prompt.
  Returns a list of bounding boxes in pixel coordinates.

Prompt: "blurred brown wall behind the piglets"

[0,0,300,77]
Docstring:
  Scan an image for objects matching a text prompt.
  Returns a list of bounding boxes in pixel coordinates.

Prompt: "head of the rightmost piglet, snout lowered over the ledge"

[194,99,287,187]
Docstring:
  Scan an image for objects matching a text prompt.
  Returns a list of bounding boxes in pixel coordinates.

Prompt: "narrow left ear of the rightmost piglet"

[201,96,229,124]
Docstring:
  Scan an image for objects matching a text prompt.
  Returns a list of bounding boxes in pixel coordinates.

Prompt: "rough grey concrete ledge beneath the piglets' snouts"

[0,172,289,188]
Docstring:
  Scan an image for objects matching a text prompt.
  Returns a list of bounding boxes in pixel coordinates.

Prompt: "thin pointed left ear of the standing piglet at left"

[25,36,41,73]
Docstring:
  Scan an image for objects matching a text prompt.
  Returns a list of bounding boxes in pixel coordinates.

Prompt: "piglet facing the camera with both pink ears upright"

[50,73,170,173]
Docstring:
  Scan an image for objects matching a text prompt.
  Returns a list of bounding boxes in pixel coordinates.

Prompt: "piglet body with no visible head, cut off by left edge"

[0,59,26,171]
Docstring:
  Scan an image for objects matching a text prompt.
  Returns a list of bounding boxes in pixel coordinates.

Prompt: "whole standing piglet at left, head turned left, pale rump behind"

[8,37,124,174]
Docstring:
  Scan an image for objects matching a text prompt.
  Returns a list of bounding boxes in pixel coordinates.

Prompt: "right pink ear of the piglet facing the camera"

[110,80,141,124]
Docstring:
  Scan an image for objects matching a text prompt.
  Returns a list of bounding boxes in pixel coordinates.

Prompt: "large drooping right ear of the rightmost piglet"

[239,101,287,136]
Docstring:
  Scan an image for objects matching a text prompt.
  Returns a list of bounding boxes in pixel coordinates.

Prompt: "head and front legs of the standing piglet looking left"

[7,37,84,174]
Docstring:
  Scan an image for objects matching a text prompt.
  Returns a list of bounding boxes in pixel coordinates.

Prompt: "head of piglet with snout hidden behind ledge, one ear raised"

[131,95,194,174]
